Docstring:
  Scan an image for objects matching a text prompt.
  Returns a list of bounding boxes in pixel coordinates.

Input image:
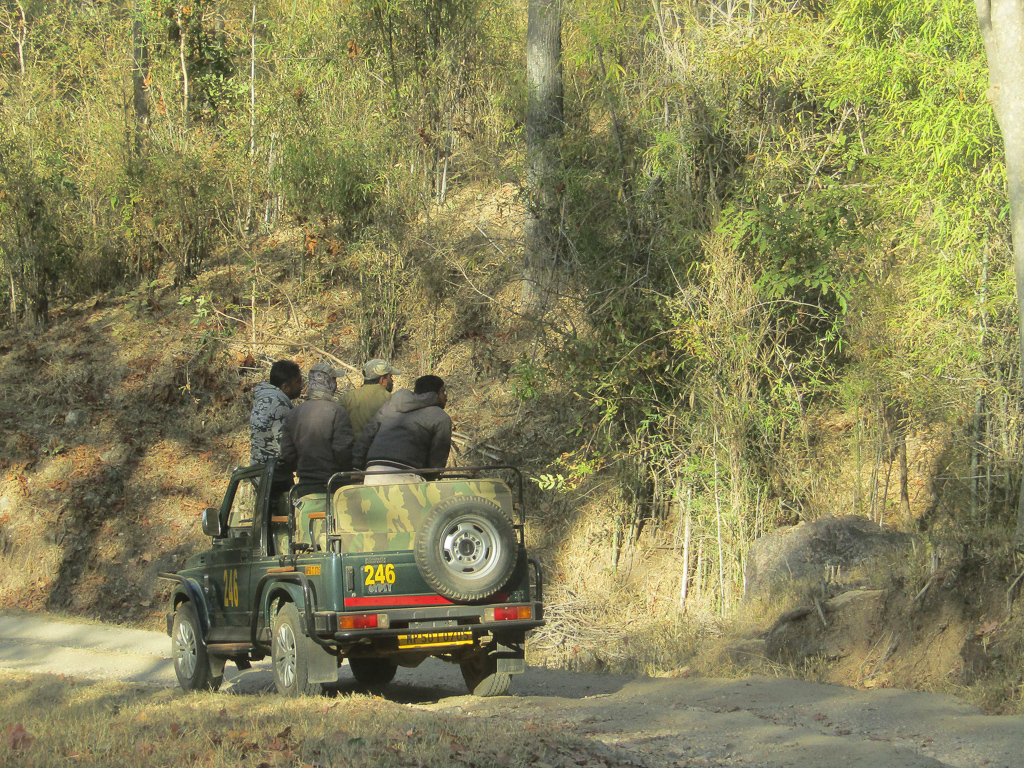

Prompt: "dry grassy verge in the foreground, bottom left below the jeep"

[0,671,617,768]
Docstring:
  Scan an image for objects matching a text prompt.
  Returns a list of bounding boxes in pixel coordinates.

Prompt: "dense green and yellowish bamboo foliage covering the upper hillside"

[0,0,1021,606]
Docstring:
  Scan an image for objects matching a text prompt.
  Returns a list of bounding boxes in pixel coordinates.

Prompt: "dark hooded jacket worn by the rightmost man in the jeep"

[352,389,452,479]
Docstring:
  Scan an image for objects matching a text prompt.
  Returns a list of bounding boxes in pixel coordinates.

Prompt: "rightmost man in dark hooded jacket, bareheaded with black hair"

[353,376,452,485]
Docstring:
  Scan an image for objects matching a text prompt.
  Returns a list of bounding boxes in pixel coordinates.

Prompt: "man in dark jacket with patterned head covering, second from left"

[281,362,353,485]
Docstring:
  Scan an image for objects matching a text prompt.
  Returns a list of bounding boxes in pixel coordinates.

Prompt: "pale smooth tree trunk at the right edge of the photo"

[975,0,1024,549]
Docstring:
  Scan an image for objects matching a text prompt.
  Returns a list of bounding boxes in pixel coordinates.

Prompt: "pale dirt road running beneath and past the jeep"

[0,616,1024,768]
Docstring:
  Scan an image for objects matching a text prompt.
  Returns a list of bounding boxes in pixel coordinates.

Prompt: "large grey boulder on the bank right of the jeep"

[743,515,913,599]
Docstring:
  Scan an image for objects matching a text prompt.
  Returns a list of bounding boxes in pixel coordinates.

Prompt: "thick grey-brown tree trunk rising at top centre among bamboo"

[522,0,563,313]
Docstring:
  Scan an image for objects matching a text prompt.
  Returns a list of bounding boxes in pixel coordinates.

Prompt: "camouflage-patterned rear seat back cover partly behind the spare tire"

[332,479,513,553]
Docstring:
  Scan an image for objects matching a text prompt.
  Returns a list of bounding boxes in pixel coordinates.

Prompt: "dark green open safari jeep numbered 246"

[160,462,544,696]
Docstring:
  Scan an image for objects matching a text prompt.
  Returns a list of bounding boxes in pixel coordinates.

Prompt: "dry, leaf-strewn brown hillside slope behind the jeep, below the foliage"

[0,210,1021,709]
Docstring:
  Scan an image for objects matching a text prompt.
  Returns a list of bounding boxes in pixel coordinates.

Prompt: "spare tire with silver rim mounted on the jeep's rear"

[415,496,518,602]
